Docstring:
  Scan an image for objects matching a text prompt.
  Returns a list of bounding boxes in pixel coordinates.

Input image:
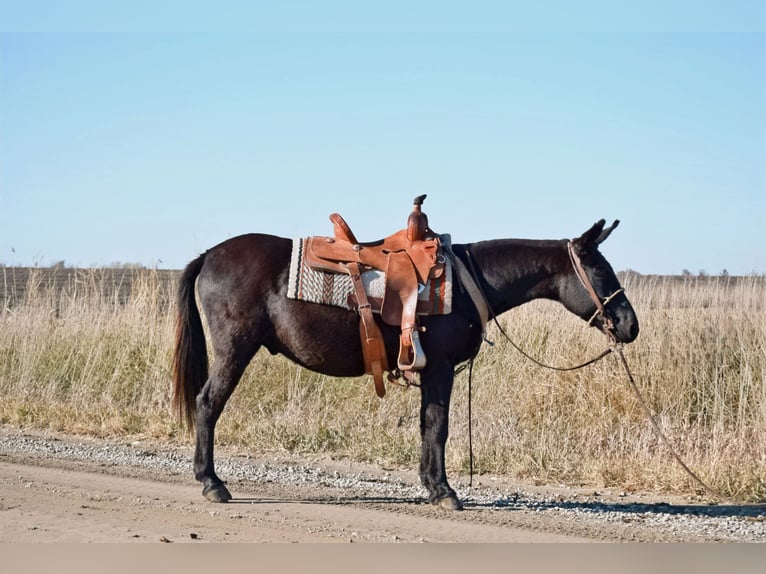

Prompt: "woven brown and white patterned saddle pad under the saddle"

[287,239,452,315]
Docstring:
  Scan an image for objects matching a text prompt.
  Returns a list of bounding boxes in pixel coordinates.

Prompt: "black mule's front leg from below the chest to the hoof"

[420,364,462,510]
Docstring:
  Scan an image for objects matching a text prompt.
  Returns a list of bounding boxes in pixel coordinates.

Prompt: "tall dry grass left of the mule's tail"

[0,269,174,436]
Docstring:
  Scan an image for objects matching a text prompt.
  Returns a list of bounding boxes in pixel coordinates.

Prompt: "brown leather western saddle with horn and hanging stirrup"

[304,195,445,397]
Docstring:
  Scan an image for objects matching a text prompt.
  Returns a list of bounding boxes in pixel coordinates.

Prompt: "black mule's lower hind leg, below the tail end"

[194,355,252,502]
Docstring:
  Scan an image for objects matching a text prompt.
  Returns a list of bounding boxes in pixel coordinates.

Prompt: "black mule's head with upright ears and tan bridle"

[559,219,638,343]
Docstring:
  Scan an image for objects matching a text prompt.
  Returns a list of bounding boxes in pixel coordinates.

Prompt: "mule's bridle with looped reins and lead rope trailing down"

[456,241,732,501]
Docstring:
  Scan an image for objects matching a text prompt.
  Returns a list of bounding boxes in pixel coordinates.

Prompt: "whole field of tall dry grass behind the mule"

[0,268,766,501]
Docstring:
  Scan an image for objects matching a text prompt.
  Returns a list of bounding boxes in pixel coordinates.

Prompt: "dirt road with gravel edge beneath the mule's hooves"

[0,429,766,543]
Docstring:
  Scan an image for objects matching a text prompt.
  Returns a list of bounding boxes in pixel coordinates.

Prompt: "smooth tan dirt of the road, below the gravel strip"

[0,462,587,542]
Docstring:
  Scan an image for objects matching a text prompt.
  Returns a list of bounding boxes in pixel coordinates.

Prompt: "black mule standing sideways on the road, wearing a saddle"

[173,220,639,509]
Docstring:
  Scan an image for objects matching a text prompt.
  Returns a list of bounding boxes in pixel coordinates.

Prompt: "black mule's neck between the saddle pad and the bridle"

[464,239,569,315]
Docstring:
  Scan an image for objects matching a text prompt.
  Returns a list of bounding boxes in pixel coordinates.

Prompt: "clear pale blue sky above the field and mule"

[0,2,766,274]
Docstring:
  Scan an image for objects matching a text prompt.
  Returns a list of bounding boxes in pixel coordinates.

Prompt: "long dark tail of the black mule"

[173,253,208,430]
